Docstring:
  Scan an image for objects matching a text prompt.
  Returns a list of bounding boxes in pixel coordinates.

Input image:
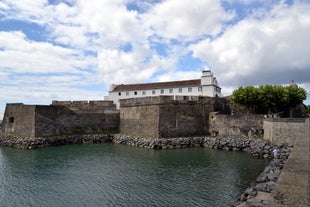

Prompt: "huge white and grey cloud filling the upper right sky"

[189,2,310,94]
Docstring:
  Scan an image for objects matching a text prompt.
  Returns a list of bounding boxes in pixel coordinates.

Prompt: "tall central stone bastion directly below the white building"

[120,96,224,138]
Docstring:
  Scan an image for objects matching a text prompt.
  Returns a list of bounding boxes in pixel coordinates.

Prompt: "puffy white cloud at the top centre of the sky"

[143,0,235,40]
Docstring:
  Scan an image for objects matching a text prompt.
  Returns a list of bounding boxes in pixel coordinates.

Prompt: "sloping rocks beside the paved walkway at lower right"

[233,145,292,207]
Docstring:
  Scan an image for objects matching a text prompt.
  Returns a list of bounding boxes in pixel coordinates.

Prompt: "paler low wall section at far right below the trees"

[264,118,305,145]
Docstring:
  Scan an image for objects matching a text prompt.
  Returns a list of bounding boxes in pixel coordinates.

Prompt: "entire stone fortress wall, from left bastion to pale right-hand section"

[0,96,303,144]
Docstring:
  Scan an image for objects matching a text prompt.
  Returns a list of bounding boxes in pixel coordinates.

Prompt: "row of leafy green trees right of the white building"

[231,85,307,117]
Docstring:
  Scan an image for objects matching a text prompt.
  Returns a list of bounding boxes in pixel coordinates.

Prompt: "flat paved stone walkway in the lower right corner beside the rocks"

[269,119,310,207]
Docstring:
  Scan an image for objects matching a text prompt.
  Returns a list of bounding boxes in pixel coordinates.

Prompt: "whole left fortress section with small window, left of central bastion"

[0,101,119,137]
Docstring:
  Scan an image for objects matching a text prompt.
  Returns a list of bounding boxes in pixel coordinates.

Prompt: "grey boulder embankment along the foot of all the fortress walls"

[0,134,273,158]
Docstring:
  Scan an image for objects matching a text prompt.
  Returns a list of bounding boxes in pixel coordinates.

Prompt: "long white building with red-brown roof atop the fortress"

[105,70,222,108]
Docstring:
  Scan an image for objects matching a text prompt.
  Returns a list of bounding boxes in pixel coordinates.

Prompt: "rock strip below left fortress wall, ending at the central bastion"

[0,135,113,149]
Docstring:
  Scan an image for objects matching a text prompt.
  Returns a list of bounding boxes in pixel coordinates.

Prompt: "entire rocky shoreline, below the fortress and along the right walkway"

[0,134,291,207]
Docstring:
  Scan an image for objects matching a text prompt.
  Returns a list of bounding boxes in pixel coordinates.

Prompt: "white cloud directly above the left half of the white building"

[98,47,175,84]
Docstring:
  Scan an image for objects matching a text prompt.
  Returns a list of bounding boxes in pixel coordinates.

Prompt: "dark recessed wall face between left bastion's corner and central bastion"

[35,105,119,136]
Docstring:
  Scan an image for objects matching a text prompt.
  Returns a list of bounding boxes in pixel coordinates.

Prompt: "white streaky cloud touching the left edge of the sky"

[0,31,95,73]
